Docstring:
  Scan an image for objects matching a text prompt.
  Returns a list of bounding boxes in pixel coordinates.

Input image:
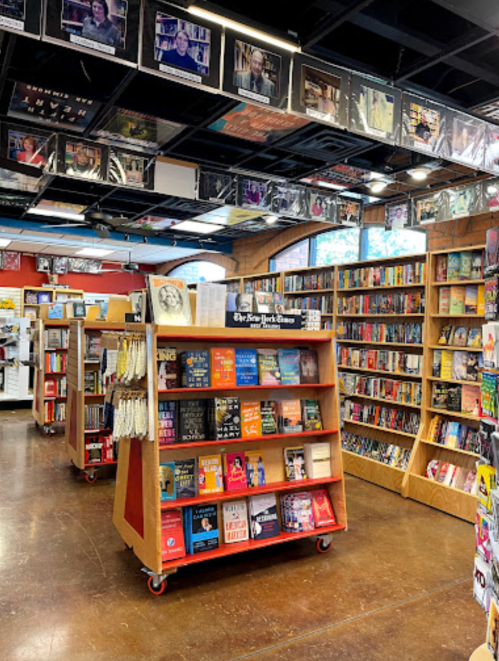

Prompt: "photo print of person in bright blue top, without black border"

[154,11,211,76]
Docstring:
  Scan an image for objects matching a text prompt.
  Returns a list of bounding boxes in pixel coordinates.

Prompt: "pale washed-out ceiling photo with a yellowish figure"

[349,75,401,143]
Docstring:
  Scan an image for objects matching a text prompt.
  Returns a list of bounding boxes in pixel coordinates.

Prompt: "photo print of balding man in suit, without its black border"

[233,39,281,98]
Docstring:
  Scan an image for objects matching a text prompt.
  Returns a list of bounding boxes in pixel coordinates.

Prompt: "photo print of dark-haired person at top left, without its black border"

[61,0,128,49]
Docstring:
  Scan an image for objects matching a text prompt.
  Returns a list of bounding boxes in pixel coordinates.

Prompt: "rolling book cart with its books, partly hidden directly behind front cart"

[66,320,125,483]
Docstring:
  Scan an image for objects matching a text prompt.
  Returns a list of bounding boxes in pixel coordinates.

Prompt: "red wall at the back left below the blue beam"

[0,255,156,294]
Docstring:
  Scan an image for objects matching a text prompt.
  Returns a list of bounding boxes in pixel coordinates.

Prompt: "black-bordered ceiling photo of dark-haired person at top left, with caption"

[45,0,140,64]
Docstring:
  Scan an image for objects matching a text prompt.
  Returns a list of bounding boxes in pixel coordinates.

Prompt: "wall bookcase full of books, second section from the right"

[333,254,427,493]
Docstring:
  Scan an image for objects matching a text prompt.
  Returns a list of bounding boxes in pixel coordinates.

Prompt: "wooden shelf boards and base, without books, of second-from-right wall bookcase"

[334,254,427,493]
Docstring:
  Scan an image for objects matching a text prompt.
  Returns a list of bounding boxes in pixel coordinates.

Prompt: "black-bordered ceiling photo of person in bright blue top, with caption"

[140,0,222,90]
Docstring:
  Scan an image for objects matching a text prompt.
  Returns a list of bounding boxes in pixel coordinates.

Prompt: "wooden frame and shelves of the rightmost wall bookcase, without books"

[402,245,485,523]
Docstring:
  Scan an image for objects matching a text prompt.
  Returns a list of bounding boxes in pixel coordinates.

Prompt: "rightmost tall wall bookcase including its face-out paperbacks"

[402,245,485,523]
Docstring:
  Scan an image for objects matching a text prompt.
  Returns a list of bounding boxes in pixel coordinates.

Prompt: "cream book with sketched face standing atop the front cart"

[146,275,192,326]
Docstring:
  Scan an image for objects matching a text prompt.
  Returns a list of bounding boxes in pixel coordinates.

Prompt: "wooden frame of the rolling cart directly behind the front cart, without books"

[66,320,125,484]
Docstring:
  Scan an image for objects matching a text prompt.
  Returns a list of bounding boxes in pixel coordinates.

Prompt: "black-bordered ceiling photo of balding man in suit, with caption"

[222,28,291,110]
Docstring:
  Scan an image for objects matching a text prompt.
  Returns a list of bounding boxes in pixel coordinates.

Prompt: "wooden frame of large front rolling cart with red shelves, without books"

[113,324,347,594]
